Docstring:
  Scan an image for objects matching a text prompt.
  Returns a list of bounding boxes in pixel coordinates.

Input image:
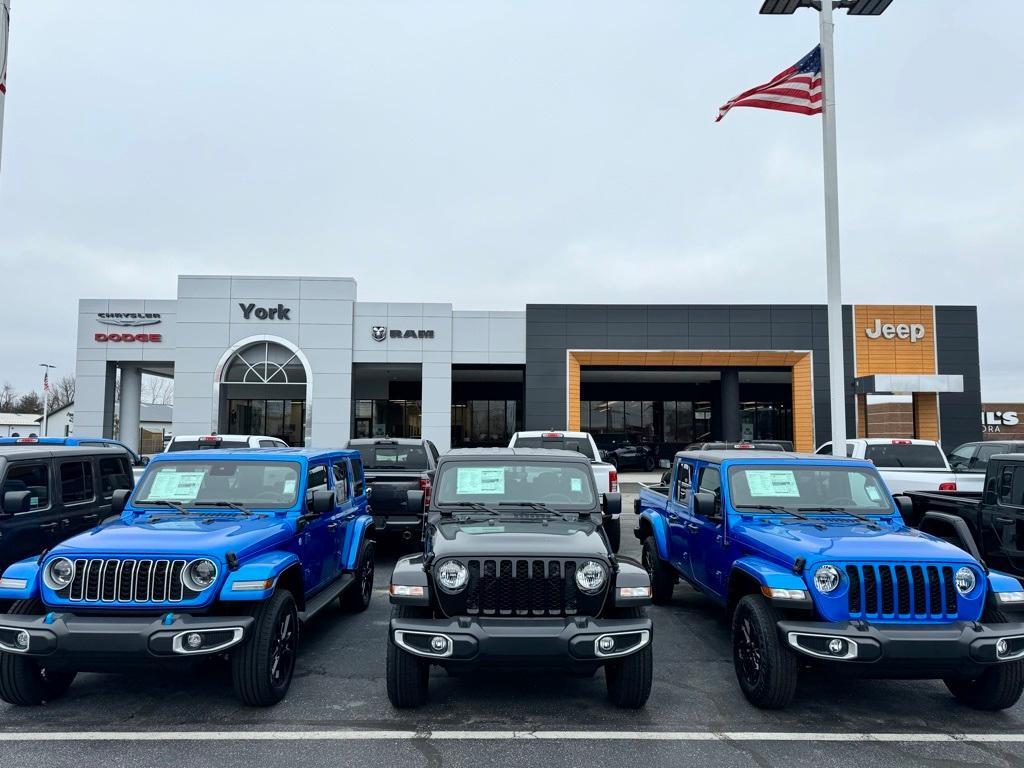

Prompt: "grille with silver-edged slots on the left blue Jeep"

[56,559,200,604]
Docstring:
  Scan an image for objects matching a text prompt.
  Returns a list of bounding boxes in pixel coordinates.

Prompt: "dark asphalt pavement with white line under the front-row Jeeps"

[0,493,1024,768]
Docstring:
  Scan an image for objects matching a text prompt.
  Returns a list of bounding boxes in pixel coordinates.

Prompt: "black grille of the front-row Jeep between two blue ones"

[436,558,607,616]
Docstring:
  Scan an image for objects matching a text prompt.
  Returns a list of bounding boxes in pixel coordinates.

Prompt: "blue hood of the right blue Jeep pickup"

[731,518,973,564]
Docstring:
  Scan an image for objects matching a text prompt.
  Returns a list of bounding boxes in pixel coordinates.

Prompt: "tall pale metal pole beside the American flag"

[818,0,846,456]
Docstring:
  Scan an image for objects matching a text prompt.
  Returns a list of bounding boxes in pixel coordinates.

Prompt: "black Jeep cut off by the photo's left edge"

[0,444,134,599]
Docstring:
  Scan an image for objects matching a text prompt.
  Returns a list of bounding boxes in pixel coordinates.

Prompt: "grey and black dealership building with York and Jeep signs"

[75,275,982,455]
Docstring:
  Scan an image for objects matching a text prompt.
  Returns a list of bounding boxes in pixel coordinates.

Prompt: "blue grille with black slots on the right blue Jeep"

[846,564,959,618]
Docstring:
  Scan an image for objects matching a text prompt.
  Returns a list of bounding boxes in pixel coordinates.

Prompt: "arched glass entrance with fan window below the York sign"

[217,338,310,445]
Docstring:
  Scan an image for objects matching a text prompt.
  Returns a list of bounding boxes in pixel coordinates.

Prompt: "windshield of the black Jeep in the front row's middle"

[434,461,595,507]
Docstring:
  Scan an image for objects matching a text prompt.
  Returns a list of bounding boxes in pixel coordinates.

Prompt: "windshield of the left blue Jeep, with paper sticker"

[132,461,299,509]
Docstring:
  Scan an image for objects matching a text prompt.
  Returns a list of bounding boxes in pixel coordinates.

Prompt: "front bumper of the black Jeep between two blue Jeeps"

[390,616,653,667]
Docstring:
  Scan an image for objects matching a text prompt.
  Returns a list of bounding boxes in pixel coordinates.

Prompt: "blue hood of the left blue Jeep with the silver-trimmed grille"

[50,514,293,560]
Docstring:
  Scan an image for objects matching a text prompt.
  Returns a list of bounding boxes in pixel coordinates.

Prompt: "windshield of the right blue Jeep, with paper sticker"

[729,466,892,514]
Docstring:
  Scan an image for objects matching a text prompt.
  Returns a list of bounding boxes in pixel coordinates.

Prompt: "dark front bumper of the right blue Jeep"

[778,621,1024,673]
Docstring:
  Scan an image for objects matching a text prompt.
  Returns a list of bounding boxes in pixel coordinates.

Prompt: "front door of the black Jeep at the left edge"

[0,459,59,567]
